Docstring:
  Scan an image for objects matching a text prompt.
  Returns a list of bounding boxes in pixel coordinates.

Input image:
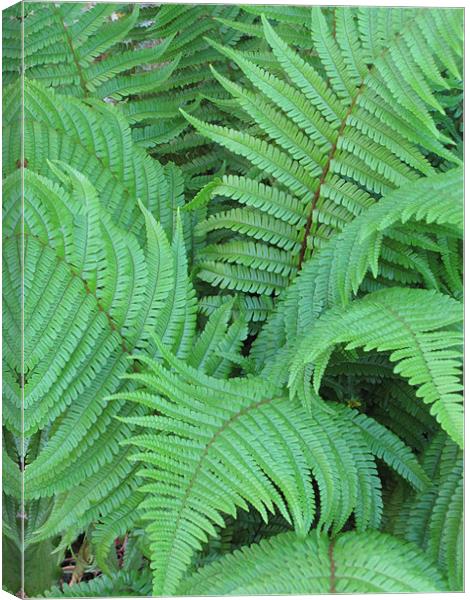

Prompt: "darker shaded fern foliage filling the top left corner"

[8,2,264,187]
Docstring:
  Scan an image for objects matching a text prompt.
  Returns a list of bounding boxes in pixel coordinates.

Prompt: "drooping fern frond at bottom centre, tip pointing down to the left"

[118,338,426,594]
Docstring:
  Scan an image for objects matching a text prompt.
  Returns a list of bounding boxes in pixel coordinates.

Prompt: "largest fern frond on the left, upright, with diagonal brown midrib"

[4,155,196,552]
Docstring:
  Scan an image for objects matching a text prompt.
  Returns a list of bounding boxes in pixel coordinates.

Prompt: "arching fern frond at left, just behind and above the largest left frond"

[5,82,174,233]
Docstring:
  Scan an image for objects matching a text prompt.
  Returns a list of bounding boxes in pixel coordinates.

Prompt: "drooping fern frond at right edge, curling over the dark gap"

[290,288,463,445]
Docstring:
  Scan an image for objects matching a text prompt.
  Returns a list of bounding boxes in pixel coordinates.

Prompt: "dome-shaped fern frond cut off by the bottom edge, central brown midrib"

[179,531,446,595]
